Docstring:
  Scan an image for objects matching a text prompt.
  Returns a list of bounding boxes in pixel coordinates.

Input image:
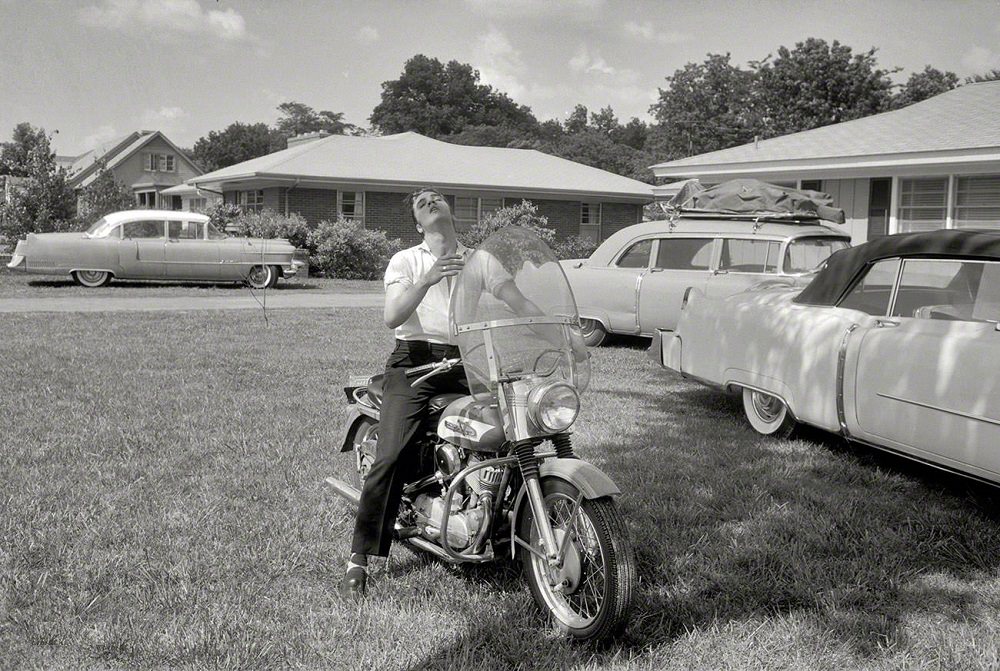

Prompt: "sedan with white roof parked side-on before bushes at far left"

[7,210,300,289]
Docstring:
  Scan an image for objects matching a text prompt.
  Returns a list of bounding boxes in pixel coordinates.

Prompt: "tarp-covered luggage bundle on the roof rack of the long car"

[667,179,846,224]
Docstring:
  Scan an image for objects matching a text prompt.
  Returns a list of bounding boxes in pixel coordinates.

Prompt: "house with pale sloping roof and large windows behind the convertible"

[652,81,1000,243]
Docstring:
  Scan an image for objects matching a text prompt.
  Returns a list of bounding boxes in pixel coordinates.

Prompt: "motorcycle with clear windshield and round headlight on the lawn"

[326,227,636,640]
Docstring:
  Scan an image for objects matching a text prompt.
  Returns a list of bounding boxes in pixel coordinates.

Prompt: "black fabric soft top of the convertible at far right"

[794,230,1000,305]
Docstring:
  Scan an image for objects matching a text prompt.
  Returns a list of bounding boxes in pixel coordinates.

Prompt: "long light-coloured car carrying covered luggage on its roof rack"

[562,218,851,347]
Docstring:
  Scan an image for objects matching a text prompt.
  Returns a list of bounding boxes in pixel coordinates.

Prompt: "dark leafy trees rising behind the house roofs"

[0,37,1000,244]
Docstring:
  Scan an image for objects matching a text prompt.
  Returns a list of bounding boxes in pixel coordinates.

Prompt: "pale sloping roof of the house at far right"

[652,81,1000,176]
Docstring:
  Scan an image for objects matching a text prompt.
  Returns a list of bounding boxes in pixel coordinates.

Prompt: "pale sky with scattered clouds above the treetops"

[0,0,1000,155]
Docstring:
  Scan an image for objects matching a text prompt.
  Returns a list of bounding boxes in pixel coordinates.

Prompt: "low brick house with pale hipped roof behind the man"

[187,132,653,243]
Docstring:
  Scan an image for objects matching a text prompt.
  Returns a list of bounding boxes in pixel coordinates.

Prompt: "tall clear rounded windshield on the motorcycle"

[450,226,590,394]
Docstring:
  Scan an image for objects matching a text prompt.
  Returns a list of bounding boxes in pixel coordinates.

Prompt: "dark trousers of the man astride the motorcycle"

[351,340,469,557]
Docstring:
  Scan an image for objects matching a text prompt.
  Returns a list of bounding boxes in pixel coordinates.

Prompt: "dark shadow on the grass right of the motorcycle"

[394,386,1000,669]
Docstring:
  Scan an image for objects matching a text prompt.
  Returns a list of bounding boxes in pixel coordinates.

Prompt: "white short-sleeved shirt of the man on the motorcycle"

[384,242,511,344]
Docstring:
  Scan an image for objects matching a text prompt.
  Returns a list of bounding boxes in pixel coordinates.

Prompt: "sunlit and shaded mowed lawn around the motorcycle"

[0,309,1000,669]
